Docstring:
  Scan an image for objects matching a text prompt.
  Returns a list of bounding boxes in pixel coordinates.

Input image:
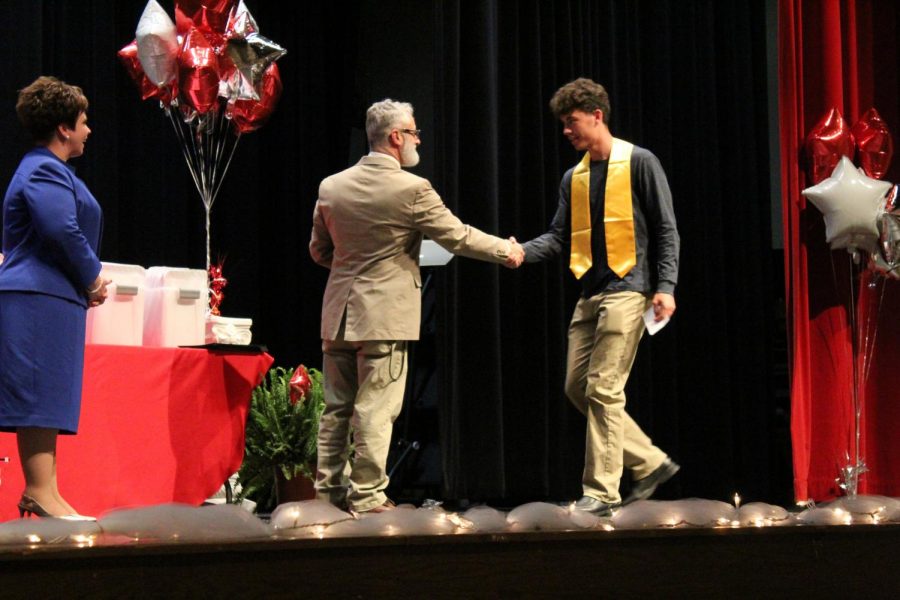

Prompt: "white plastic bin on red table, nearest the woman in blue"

[85,262,146,346]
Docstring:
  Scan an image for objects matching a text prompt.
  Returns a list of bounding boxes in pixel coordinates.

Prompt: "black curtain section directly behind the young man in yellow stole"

[435,0,790,501]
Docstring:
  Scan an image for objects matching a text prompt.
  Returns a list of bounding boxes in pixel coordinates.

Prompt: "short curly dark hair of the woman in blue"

[16,75,88,142]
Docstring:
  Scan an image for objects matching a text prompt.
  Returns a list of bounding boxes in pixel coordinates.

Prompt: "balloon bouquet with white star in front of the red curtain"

[803,108,900,496]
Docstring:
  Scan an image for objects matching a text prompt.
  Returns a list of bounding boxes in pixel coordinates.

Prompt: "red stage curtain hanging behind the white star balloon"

[779,0,900,500]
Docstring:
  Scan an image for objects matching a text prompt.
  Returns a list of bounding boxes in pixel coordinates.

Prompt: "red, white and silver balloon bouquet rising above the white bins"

[118,0,286,310]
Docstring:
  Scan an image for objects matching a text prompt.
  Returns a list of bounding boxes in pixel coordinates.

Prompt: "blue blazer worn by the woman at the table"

[0,147,103,307]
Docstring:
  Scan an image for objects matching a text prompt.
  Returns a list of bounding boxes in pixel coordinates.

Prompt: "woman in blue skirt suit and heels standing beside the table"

[0,77,109,519]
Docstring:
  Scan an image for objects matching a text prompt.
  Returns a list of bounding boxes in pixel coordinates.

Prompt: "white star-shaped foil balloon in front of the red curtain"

[803,156,891,253]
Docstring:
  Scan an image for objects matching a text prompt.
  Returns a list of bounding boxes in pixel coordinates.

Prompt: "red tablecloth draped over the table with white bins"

[0,345,273,521]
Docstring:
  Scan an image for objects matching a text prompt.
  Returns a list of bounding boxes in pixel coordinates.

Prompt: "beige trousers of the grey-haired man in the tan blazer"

[316,327,407,511]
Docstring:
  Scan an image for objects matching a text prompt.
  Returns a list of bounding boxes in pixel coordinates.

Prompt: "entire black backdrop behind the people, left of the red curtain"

[0,0,790,505]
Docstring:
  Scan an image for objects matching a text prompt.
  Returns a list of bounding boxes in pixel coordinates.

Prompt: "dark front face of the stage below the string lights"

[0,524,900,598]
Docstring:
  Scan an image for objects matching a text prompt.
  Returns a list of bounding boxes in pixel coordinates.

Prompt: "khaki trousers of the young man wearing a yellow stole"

[566,292,666,504]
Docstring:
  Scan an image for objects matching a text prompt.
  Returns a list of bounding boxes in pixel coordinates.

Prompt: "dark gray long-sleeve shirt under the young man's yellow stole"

[523,146,681,298]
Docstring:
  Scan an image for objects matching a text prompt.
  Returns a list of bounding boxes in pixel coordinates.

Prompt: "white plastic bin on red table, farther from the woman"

[144,267,209,348]
